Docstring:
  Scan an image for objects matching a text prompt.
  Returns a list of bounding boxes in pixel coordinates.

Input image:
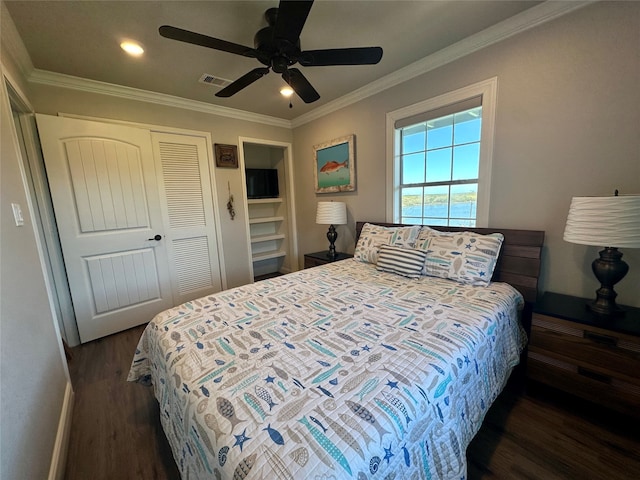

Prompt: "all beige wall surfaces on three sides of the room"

[0,2,640,478]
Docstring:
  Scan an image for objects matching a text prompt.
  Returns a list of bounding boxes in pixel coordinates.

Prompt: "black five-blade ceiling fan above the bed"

[159,0,382,103]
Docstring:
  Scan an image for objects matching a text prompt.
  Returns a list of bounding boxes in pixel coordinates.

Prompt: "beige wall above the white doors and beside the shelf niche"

[31,84,292,287]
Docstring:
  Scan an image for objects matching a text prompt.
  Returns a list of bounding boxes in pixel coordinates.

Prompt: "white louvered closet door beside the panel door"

[151,132,223,304]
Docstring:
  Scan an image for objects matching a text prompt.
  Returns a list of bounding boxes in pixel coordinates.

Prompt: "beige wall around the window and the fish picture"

[293,2,640,306]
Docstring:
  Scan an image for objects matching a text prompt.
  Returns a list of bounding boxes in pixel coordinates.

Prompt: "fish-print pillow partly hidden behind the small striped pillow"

[353,223,420,265]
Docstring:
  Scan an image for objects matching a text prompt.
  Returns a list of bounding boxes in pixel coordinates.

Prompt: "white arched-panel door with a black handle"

[36,115,174,342]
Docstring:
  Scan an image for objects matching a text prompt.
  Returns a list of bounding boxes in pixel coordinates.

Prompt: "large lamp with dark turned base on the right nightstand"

[564,190,640,317]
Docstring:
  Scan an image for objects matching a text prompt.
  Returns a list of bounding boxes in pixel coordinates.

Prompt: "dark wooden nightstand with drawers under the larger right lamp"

[527,292,640,417]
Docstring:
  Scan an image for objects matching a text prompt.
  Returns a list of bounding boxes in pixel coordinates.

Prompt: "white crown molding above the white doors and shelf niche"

[29,69,291,129]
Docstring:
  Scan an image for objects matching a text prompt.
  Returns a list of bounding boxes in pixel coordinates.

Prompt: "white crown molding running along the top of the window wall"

[291,0,597,128]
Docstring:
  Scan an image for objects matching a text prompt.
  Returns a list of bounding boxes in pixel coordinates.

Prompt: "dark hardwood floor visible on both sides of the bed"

[65,327,640,480]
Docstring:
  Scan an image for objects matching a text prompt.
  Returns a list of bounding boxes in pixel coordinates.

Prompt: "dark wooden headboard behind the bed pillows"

[356,222,544,304]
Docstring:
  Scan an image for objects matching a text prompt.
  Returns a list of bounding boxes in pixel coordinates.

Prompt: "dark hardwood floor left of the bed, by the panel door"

[65,326,180,480]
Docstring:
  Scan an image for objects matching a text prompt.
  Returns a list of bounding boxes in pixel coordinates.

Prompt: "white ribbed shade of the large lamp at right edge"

[564,195,640,248]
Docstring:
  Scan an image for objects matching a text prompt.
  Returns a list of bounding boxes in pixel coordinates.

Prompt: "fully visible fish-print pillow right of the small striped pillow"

[421,230,504,285]
